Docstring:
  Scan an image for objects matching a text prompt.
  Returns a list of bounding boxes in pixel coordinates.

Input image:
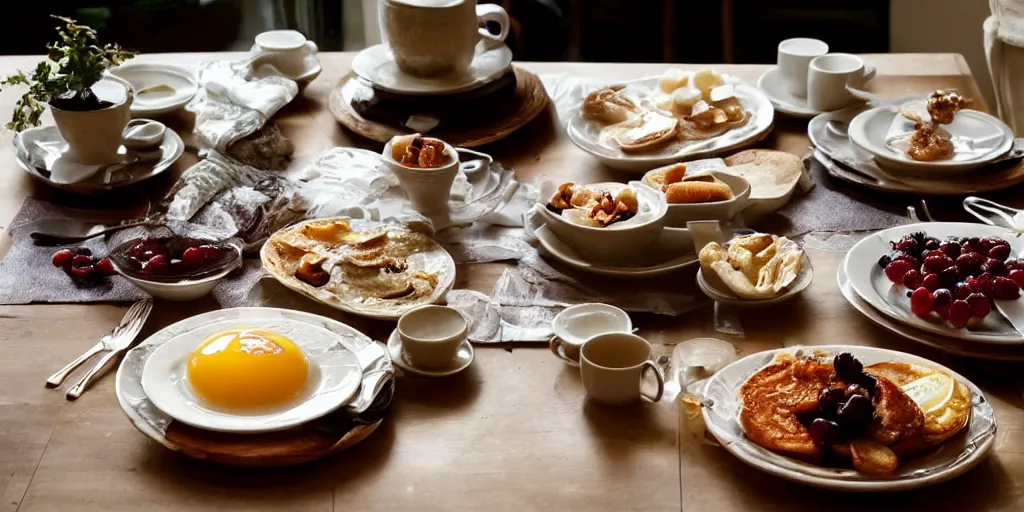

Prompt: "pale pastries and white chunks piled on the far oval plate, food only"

[581,68,751,154]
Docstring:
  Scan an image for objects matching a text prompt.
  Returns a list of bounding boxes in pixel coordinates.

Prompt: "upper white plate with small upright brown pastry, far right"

[847,90,1014,175]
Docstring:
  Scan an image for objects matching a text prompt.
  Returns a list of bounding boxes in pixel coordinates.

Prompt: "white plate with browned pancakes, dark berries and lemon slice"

[701,345,996,492]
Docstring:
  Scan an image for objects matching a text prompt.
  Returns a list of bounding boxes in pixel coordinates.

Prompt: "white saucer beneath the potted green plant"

[13,126,185,194]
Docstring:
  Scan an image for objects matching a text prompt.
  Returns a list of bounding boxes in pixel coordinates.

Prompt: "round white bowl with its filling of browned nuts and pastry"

[536,182,667,263]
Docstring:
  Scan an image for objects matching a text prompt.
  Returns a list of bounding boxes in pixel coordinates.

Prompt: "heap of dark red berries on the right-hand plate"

[879,231,1024,329]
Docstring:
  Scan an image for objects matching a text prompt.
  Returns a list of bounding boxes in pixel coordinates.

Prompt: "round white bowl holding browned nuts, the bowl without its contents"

[537,182,667,263]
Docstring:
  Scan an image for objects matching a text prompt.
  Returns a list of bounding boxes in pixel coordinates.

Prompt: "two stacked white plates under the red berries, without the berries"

[838,222,1024,360]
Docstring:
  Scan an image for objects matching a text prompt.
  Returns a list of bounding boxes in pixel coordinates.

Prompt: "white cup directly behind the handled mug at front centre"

[548,303,633,365]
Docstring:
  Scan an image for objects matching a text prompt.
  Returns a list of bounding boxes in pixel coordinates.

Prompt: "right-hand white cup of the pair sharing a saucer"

[807,53,873,112]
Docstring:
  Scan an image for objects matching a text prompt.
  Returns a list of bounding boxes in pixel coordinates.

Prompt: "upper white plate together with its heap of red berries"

[844,222,1024,344]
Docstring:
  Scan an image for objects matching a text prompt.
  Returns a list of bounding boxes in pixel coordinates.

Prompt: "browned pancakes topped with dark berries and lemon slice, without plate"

[739,351,972,475]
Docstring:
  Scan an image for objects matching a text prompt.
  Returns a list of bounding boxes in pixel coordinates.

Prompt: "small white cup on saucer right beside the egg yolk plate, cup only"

[398,305,469,370]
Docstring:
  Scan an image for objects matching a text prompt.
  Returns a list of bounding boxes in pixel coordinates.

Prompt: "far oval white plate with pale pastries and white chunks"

[566,68,774,172]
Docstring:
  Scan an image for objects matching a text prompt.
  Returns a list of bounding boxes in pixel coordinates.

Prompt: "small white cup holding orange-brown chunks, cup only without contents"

[381,138,459,213]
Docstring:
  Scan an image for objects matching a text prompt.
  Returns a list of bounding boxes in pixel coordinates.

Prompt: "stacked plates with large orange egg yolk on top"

[116,307,393,467]
